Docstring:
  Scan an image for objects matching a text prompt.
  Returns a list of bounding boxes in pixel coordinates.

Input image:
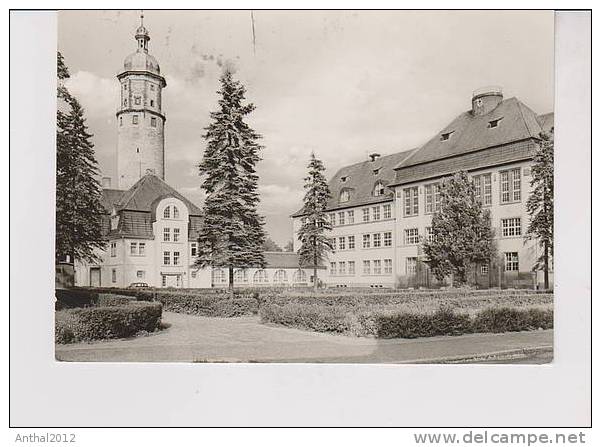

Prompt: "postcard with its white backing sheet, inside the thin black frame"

[9,5,592,434]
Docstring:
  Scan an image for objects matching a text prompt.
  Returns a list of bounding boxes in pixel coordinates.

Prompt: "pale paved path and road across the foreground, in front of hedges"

[56,312,553,363]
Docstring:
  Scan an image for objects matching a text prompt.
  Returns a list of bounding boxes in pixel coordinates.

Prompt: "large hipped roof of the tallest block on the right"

[396,98,542,172]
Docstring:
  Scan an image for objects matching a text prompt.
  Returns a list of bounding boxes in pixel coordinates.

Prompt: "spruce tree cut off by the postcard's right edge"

[526,131,554,289]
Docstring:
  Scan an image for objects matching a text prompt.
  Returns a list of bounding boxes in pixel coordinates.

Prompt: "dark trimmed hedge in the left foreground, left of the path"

[55,302,162,343]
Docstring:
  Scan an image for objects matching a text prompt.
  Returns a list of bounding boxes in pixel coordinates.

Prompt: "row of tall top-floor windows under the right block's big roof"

[403,168,522,216]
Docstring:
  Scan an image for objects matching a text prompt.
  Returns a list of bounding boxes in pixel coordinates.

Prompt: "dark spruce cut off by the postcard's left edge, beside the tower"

[55,53,105,262]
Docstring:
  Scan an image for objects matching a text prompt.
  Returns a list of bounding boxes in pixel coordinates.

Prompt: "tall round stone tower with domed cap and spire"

[117,14,167,189]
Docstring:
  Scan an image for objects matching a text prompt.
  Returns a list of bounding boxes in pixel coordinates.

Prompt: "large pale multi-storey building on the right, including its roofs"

[293,88,553,287]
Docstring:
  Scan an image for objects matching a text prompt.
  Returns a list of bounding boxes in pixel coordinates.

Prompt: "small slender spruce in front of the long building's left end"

[298,153,334,290]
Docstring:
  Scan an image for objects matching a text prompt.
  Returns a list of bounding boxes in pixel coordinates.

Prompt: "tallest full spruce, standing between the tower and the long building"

[196,69,265,292]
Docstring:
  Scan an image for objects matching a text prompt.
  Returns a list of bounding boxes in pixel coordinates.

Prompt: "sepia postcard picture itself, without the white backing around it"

[55,11,554,363]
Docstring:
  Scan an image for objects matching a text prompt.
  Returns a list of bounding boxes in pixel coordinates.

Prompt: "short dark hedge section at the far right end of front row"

[473,307,553,332]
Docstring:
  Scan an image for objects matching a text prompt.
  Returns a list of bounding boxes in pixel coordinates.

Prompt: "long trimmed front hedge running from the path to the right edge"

[260,302,553,338]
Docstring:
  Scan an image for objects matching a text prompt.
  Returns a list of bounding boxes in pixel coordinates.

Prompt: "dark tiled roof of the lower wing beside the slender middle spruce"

[292,150,413,217]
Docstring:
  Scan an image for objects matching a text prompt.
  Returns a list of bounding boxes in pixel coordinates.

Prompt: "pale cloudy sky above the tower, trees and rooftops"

[58,11,554,246]
